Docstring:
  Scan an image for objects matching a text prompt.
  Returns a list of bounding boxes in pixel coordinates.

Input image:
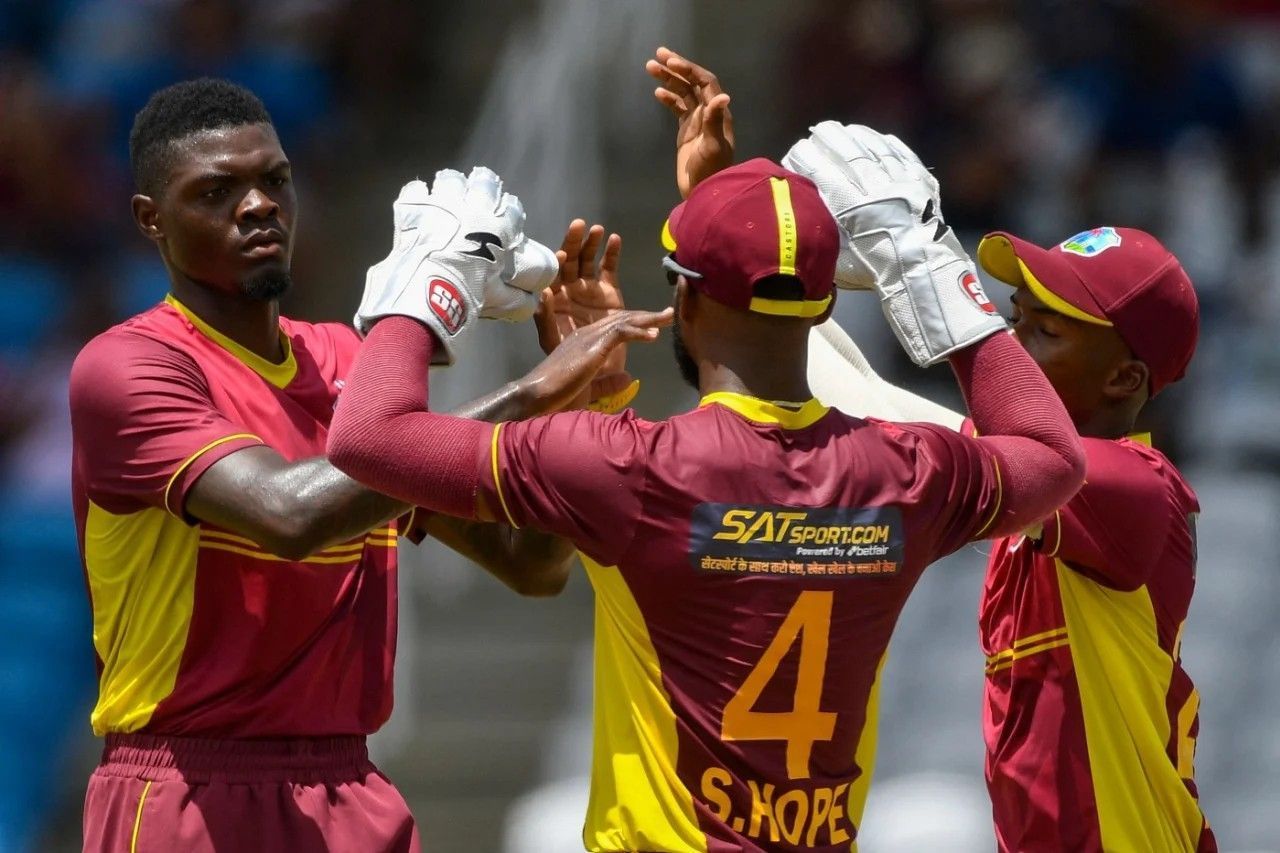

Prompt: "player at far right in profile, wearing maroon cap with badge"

[646,49,1217,853]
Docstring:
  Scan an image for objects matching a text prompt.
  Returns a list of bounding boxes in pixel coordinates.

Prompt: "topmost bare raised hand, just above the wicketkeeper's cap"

[644,47,733,199]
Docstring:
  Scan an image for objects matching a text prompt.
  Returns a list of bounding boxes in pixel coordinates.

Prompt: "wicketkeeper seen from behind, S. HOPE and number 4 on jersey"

[329,146,1083,853]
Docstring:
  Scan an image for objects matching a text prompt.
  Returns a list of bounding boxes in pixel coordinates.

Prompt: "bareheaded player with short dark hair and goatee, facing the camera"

[70,79,619,852]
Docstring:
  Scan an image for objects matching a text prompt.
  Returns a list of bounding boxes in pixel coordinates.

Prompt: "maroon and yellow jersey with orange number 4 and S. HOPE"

[479,393,1000,853]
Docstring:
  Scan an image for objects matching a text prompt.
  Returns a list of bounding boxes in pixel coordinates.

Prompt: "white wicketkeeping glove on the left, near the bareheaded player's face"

[355,167,559,365]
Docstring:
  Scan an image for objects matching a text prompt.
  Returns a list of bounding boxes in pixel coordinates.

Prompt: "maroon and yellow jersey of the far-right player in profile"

[979,435,1217,852]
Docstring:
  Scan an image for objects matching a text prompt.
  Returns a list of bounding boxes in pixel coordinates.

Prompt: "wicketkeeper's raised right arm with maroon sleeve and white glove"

[783,122,1084,535]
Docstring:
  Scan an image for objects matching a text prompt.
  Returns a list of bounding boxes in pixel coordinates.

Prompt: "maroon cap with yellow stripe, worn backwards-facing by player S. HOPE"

[662,158,840,316]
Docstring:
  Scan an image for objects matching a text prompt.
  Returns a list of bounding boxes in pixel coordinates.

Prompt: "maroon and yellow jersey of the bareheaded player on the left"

[70,297,396,738]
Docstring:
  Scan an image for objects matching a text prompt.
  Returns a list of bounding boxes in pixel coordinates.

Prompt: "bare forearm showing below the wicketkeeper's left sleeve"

[426,515,573,597]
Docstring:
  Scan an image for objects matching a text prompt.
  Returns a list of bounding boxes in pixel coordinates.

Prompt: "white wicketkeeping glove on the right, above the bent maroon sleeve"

[782,122,1007,366]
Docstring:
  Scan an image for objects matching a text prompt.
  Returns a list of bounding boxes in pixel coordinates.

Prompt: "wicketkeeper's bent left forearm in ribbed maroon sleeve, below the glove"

[329,316,493,519]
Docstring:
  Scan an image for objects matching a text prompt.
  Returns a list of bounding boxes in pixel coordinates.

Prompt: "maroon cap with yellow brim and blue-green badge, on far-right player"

[978,227,1199,396]
